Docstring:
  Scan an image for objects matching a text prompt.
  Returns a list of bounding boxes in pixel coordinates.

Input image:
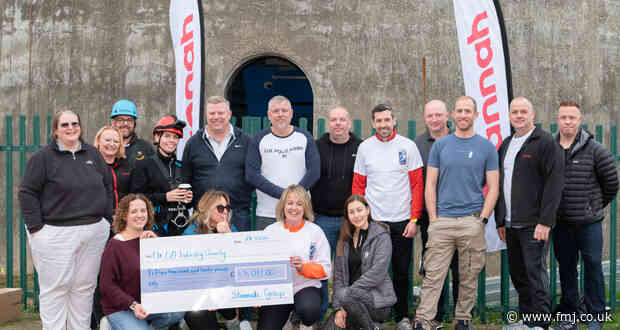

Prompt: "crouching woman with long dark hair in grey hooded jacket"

[324,195,396,330]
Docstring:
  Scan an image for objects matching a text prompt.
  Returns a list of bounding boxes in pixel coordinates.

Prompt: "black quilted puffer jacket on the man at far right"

[556,129,618,224]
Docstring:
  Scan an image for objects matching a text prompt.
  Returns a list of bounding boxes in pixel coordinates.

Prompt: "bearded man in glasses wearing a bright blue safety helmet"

[110,100,154,170]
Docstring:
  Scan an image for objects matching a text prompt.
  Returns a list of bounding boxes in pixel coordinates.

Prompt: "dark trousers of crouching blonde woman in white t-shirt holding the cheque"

[258,287,321,330]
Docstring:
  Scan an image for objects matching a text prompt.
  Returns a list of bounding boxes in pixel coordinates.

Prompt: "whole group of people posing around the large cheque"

[19,96,618,330]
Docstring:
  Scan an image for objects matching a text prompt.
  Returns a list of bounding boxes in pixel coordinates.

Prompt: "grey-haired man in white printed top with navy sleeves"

[245,95,321,230]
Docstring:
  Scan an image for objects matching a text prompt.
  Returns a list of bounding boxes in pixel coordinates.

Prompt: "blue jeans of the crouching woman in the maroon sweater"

[106,310,185,330]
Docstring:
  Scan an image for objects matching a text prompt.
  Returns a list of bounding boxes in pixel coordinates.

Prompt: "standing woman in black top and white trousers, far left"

[19,110,114,329]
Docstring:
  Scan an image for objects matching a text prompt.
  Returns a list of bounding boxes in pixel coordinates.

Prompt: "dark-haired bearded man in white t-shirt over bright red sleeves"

[352,104,424,329]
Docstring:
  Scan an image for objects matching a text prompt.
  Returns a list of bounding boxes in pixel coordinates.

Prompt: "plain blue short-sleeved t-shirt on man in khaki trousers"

[428,134,499,217]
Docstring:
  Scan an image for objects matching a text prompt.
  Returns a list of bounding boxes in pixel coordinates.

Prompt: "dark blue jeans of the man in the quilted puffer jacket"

[553,221,605,315]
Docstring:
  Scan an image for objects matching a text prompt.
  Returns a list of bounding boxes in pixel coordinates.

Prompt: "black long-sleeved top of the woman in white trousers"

[19,141,114,233]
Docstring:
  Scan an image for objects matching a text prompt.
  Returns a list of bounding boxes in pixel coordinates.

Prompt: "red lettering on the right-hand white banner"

[467,11,502,148]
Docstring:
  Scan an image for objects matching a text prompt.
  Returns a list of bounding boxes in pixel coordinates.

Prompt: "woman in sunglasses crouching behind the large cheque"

[183,190,239,330]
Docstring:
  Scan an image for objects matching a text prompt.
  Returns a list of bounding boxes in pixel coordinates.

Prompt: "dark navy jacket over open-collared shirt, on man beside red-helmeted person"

[182,127,253,209]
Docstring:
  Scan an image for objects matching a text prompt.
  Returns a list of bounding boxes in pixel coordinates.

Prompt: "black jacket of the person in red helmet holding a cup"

[129,152,189,236]
